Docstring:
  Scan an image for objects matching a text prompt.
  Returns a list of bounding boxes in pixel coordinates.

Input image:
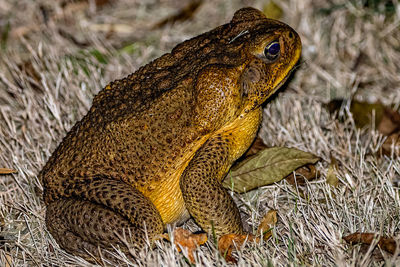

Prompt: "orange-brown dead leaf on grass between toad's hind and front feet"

[167,228,207,263]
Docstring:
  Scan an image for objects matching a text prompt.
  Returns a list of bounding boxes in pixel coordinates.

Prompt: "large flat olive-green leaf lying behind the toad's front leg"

[222,147,320,193]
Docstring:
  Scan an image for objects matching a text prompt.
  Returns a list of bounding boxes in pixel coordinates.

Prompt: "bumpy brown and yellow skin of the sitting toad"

[40,8,301,259]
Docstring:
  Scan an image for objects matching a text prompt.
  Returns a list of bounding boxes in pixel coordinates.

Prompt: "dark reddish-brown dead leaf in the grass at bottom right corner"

[343,232,397,254]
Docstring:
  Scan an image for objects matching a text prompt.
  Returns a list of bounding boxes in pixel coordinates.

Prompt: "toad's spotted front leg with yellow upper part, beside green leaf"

[180,109,261,237]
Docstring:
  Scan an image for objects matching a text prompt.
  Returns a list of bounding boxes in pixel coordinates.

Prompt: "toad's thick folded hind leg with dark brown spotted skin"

[46,178,164,261]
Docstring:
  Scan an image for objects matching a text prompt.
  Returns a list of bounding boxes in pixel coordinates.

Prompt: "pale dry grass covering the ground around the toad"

[0,0,400,266]
